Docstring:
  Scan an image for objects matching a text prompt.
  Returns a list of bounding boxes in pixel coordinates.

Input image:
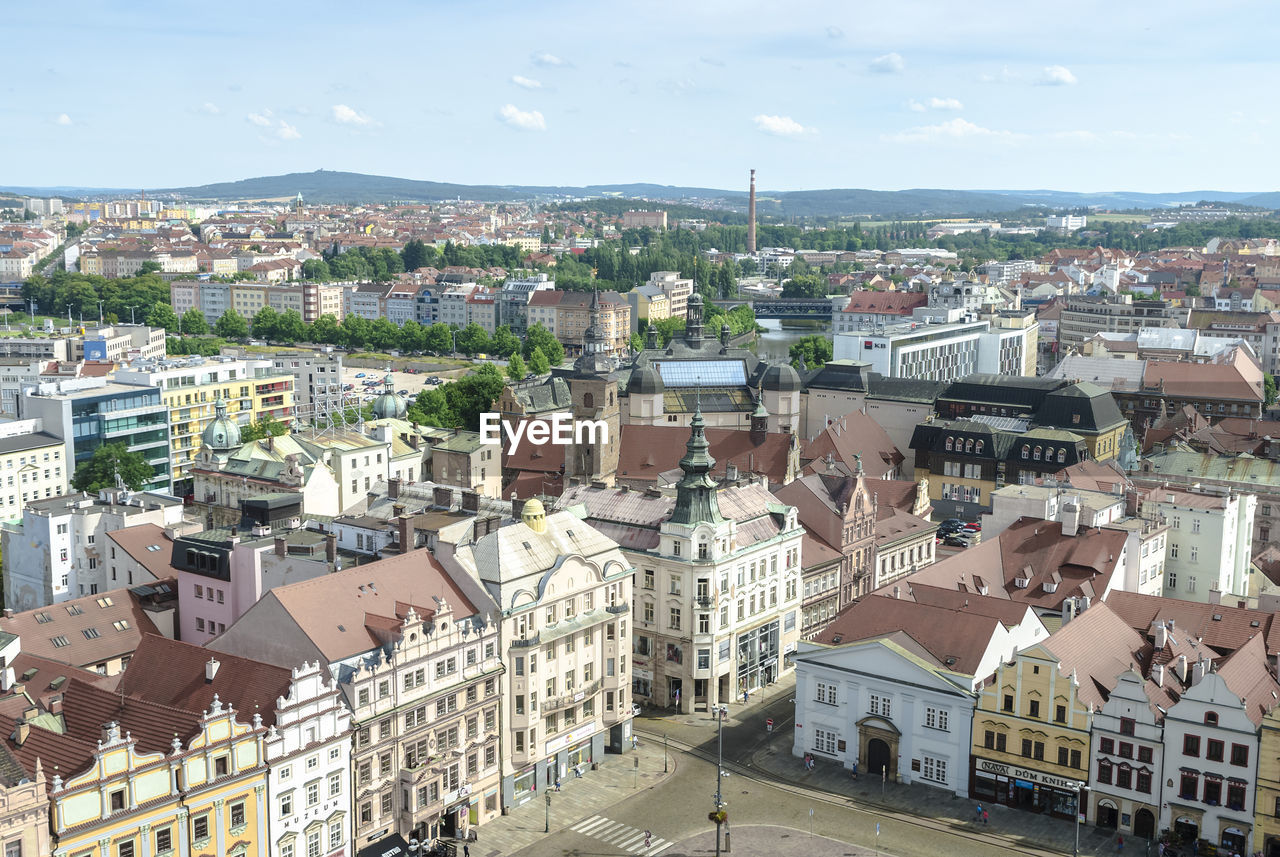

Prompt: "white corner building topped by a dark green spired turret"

[561,411,804,712]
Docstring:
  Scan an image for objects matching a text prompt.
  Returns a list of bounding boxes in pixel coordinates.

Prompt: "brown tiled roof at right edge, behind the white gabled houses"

[1107,590,1280,656]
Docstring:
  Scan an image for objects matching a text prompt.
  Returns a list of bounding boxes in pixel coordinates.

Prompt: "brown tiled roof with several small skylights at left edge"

[0,588,159,668]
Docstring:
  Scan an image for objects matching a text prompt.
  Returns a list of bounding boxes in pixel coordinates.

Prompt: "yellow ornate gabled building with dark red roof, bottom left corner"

[5,679,270,857]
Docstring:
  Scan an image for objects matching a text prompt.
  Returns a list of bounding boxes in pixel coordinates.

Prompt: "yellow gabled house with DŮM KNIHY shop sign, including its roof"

[969,602,1135,819]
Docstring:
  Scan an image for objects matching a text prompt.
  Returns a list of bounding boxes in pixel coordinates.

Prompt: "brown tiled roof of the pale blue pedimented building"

[814,595,1000,675]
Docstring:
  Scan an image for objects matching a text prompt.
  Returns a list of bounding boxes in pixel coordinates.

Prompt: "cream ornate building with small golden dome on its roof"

[435,499,635,807]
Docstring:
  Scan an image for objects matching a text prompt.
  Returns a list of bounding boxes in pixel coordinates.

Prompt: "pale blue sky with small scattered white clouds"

[0,0,1280,192]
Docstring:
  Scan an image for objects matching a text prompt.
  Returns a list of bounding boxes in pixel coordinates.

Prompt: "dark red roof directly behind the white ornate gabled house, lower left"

[120,634,291,727]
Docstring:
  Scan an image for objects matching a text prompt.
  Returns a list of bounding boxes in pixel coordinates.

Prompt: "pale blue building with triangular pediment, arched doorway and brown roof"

[792,586,1048,797]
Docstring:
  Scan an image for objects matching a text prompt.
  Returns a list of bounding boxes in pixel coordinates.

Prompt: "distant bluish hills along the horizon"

[0,170,1280,217]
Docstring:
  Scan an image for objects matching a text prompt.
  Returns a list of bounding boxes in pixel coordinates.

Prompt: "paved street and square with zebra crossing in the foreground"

[455,683,1146,857]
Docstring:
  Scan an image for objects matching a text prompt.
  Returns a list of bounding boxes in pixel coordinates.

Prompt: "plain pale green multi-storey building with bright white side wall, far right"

[1142,486,1258,602]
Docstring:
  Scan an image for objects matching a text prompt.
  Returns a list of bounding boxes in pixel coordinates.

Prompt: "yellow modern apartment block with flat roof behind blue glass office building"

[115,357,293,485]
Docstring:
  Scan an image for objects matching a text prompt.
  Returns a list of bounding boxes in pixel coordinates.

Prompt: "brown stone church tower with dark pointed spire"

[564,292,622,487]
